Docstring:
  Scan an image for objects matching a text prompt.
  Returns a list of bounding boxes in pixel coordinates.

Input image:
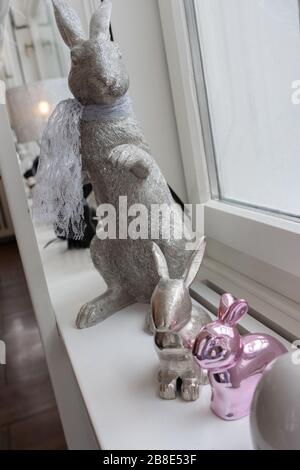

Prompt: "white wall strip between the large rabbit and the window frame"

[70,0,187,201]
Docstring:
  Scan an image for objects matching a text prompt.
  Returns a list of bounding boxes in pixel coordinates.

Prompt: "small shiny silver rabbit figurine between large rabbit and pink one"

[151,238,211,401]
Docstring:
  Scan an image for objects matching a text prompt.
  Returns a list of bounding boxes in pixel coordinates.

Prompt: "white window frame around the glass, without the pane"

[158,0,300,337]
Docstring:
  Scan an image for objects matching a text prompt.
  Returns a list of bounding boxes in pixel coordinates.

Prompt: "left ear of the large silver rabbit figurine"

[52,0,85,49]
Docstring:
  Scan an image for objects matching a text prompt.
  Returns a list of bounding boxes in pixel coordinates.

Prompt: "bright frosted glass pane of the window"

[188,0,300,217]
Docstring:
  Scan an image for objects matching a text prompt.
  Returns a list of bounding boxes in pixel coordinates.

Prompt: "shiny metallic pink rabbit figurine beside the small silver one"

[193,294,287,420]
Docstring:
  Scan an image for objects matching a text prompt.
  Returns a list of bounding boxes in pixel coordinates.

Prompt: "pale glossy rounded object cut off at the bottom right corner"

[250,350,300,450]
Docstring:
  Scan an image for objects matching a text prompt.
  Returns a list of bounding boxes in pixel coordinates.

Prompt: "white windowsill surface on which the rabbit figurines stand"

[37,229,252,450]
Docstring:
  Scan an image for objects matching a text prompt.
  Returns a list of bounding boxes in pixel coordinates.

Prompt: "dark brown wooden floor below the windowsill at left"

[0,243,66,450]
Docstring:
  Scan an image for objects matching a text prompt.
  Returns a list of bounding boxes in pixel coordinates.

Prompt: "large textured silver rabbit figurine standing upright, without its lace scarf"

[53,0,193,328]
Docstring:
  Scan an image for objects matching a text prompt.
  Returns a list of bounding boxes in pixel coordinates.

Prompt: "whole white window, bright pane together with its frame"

[159,0,300,337]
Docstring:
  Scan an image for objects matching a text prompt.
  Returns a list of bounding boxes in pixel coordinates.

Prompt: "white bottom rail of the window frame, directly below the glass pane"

[204,200,300,277]
